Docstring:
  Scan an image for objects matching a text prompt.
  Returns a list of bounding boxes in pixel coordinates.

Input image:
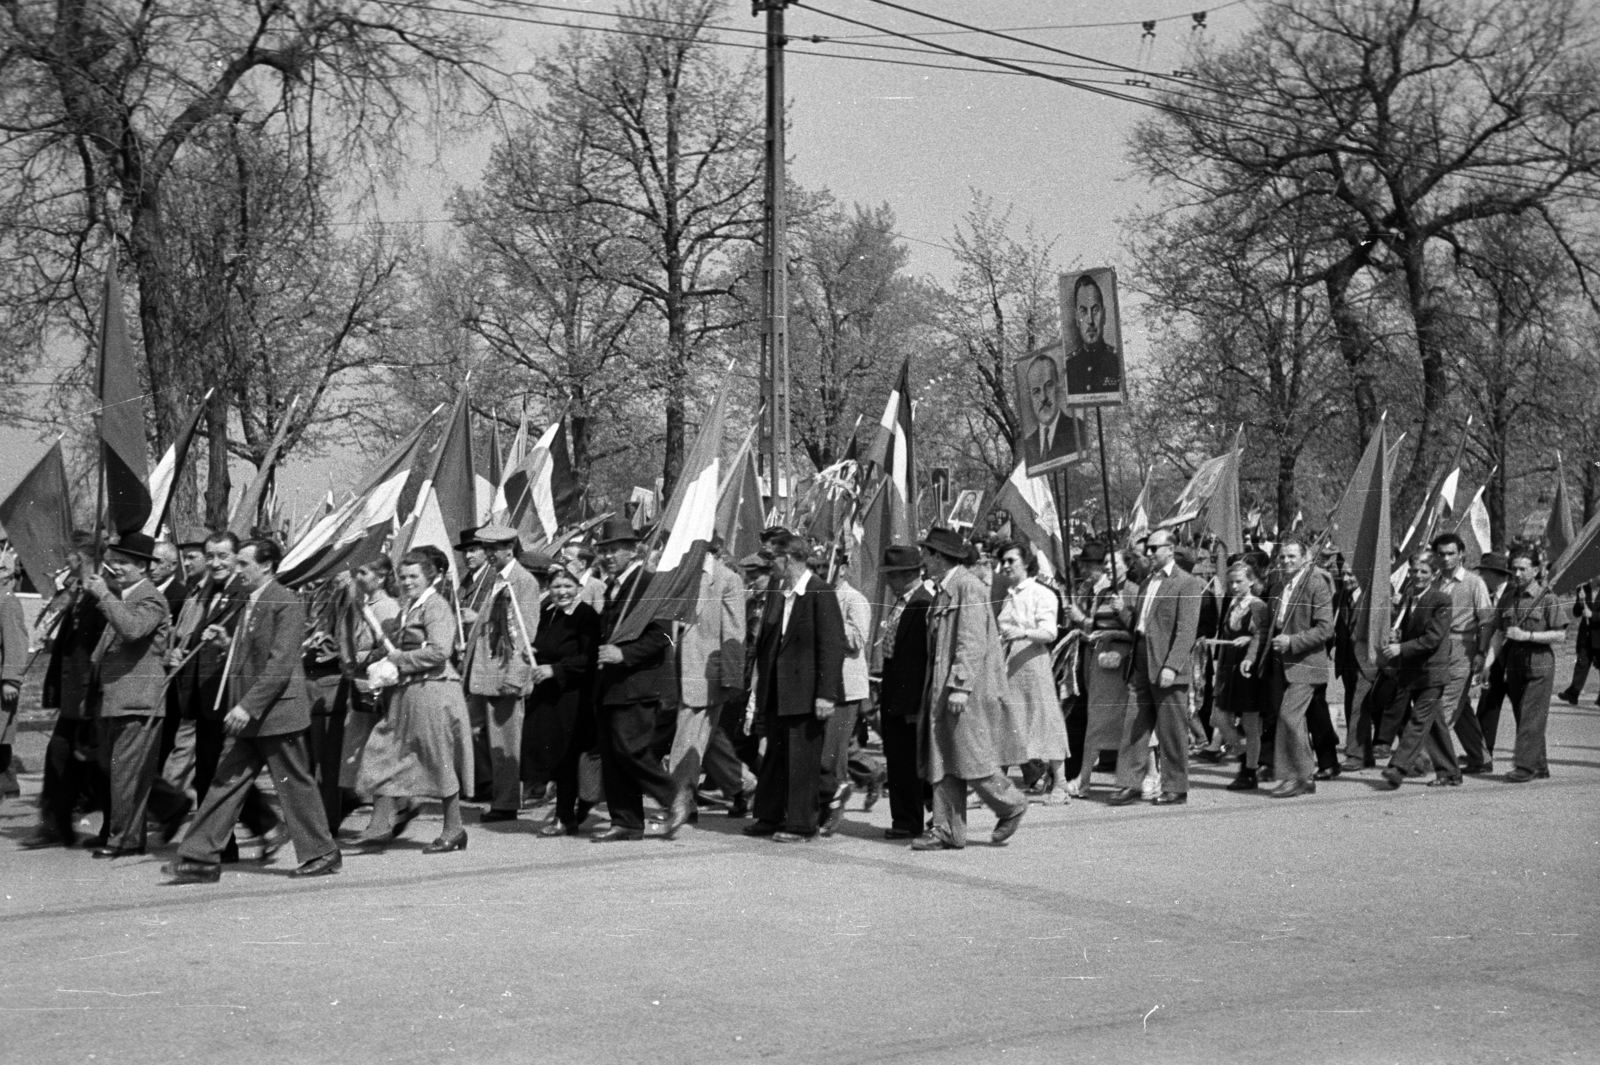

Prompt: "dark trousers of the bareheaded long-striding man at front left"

[178,732,334,865]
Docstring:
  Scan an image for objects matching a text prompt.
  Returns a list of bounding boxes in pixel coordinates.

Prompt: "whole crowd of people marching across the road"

[0,520,1580,883]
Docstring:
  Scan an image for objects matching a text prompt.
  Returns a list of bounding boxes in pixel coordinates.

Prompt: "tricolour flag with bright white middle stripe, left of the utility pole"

[611,376,733,643]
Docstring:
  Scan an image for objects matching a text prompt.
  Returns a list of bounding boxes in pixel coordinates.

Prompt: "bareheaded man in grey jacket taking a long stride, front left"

[162,540,342,883]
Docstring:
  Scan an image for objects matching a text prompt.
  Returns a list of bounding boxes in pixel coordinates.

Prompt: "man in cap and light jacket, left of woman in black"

[461,525,539,822]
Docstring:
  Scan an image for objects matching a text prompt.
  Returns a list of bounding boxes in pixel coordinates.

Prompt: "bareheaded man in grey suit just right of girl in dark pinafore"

[1267,539,1339,798]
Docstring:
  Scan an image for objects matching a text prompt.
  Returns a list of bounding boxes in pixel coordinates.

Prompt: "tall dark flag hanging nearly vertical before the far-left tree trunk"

[94,262,150,533]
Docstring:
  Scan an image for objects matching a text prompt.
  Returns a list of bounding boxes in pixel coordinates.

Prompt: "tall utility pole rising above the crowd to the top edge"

[750,0,794,523]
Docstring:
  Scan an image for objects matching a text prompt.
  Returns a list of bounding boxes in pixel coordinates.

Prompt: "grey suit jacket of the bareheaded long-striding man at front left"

[227,580,310,736]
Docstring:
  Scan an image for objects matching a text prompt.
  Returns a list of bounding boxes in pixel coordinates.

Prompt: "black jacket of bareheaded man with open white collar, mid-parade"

[755,574,845,718]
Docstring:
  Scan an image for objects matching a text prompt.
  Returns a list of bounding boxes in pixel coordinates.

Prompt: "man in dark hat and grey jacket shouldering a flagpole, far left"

[82,533,173,859]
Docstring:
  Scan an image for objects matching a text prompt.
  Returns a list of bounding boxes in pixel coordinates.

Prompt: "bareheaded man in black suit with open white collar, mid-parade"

[744,533,845,843]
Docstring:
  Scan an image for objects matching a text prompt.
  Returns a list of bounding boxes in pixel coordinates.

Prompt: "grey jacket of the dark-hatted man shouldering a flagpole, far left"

[94,580,173,718]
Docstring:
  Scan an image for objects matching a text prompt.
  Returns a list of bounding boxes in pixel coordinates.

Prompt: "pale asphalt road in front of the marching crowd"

[0,668,1600,1065]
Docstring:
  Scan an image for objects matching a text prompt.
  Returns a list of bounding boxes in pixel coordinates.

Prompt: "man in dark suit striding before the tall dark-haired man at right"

[1384,550,1461,788]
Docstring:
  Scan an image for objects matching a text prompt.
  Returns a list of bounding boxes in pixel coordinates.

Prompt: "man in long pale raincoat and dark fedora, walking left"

[912,526,1027,851]
